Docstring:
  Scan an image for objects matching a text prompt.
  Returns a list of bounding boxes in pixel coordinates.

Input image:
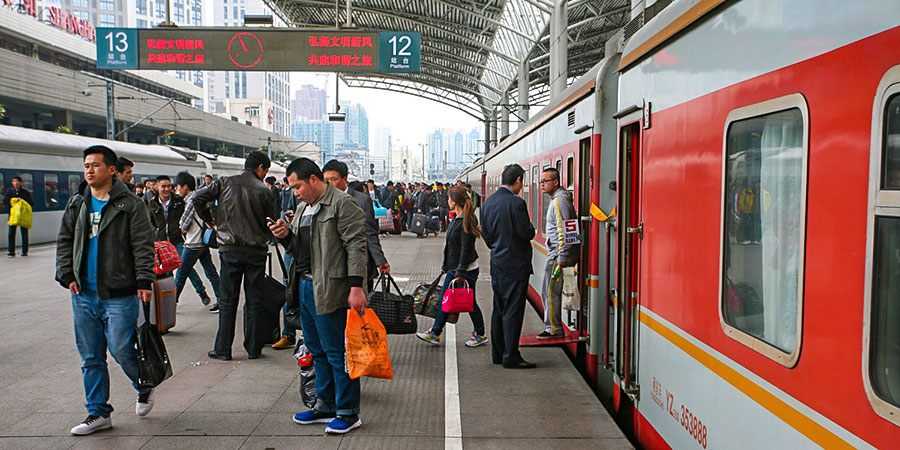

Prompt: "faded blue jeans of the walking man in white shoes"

[72,291,149,417]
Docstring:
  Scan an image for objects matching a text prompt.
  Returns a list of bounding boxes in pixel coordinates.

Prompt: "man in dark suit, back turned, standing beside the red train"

[481,164,536,369]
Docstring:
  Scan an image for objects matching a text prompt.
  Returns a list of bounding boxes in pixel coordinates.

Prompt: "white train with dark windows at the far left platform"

[0,125,285,249]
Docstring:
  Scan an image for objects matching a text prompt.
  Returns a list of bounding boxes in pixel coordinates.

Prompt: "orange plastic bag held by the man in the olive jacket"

[344,308,394,380]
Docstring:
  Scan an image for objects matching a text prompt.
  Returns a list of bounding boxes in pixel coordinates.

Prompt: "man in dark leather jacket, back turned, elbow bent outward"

[194,151,278,361]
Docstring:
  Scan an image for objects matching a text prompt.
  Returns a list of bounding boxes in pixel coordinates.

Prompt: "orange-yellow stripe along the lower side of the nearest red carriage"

[638,311,855,449]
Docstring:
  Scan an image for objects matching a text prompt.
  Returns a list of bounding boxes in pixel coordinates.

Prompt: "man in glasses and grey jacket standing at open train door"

[537,167,578,339]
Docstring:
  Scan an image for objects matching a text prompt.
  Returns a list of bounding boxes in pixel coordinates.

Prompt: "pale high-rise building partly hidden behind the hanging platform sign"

[206,0,291,136]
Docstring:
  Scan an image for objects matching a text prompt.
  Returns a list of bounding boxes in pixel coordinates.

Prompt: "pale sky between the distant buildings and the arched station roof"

[291,72,484,154]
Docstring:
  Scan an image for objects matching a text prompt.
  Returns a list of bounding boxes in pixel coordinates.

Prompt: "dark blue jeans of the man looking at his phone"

[299,278,360,416]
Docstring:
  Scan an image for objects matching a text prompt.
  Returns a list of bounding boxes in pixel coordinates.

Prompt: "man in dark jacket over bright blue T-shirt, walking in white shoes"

[56,145,156,435]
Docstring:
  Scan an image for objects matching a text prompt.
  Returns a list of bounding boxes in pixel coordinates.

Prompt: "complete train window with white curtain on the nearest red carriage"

[720,96,806,367]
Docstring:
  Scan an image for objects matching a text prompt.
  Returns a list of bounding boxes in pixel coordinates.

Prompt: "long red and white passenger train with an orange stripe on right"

[463,0,900,448]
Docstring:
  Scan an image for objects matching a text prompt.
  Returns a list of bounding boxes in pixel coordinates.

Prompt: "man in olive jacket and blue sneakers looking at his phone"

[270,158,366,434]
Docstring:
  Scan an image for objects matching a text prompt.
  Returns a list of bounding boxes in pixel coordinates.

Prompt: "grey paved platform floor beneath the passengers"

[0,233,632,450]
